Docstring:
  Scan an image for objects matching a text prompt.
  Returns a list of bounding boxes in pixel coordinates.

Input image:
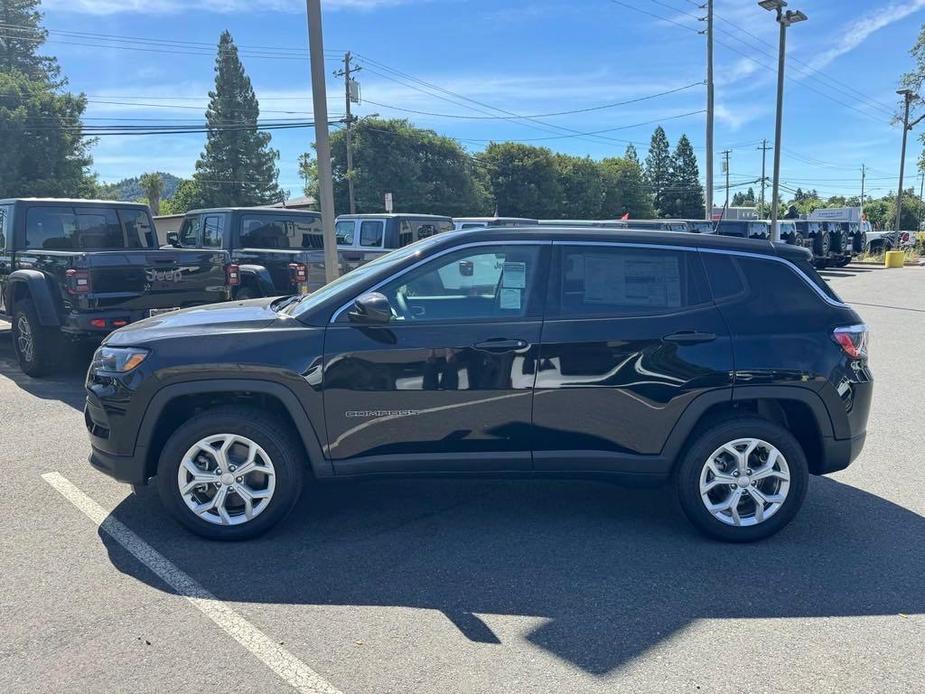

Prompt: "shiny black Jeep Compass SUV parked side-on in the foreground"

[86,227,872,541]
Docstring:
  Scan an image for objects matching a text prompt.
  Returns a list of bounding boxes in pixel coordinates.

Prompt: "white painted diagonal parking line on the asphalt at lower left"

[42,472,341,694]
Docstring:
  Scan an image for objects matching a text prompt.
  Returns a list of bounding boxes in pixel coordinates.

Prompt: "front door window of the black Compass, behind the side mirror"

[380,245,539,321]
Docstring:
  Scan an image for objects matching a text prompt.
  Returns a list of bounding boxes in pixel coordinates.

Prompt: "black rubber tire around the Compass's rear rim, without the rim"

[675,418,809,542]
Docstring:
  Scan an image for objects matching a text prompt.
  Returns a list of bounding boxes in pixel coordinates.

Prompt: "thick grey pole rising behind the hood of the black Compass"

[305,0,340,282]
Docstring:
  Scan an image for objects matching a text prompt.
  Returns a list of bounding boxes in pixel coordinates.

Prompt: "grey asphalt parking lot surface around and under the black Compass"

[0,265,925,694]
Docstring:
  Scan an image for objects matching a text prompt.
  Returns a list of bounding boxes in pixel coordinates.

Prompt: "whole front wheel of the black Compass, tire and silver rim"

[157,407,305,540]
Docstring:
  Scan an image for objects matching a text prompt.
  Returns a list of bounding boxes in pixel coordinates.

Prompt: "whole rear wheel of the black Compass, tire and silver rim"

[676,419,809,542]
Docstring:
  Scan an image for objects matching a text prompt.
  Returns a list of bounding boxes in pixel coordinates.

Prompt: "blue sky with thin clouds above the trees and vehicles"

[34,0,925,202]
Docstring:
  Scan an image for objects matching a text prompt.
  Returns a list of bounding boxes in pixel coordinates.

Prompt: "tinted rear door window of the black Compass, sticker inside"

[558,246,709,318]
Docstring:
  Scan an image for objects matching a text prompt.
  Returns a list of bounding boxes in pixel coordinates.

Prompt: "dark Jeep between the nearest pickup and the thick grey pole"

[167,207,343,299]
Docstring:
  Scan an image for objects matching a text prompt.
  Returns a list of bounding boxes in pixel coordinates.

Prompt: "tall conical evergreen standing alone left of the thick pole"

[194,31,283,207]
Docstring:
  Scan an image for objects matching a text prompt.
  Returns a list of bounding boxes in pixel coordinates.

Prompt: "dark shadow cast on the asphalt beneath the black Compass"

[100,478,925,675]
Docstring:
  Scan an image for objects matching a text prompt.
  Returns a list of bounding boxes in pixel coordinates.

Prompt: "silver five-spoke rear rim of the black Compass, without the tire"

[700,439,790,526]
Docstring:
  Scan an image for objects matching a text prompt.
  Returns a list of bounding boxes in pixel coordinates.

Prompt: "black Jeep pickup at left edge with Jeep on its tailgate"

[0,198,239,377]
